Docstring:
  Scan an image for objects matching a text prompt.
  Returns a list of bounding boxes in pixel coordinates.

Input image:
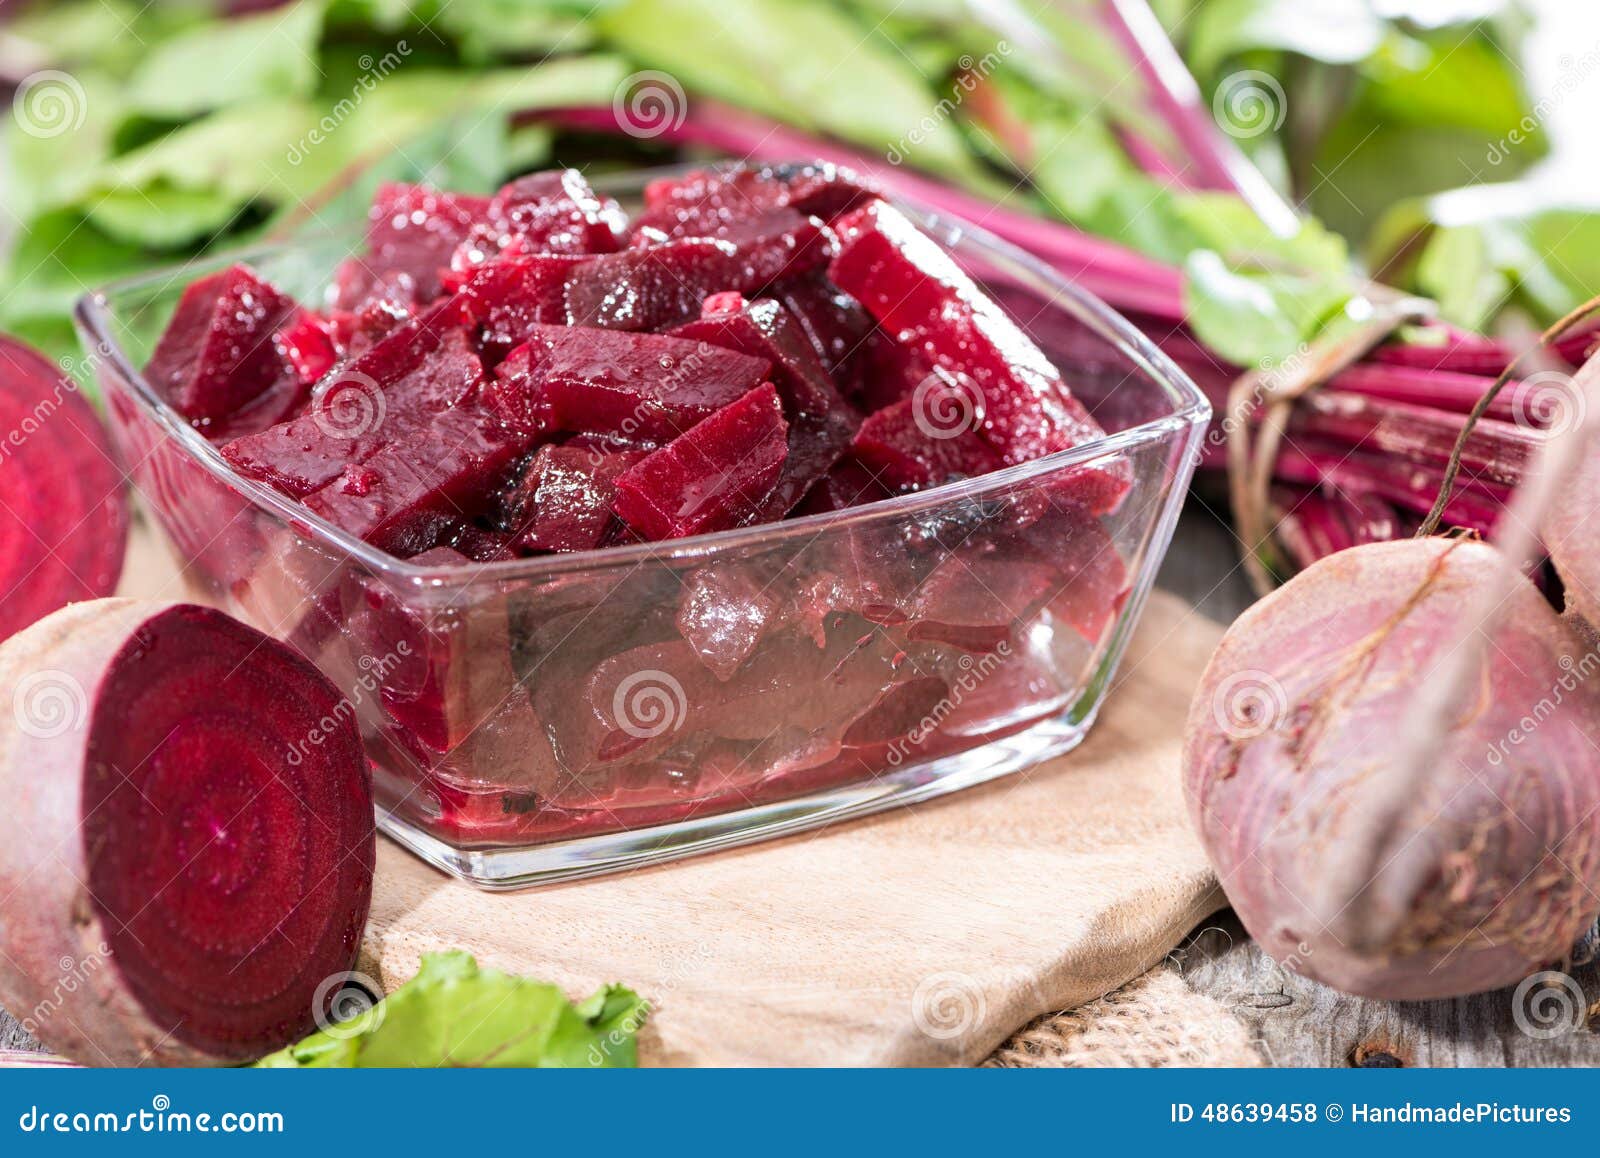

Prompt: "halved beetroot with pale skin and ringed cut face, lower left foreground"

[0,600,374,1065]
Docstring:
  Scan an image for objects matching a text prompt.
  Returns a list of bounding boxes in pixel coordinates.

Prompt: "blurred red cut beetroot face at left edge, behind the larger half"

[0,336,128,640]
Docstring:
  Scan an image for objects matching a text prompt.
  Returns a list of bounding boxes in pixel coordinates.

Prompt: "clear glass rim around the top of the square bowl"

[74,163,1211,585]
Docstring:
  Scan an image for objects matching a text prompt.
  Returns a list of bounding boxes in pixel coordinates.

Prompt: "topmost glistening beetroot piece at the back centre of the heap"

[634,165,877,237]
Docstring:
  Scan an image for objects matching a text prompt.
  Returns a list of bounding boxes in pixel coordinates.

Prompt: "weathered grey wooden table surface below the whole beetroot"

[9,499,1600,1067]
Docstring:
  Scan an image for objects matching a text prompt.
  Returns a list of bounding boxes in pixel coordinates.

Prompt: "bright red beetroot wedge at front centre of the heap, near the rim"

[613,382,789,539]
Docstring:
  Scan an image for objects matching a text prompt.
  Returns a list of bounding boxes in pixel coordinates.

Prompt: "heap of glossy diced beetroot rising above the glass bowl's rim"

[147,166,1128,560]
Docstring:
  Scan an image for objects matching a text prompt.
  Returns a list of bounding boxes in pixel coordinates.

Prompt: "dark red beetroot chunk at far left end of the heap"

[144,266,296,424]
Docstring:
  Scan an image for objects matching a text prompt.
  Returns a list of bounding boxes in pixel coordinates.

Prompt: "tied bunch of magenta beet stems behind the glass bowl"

[539,89,1595,589]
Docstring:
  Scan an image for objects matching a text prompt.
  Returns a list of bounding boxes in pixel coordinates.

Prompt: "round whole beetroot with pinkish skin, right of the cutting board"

[1184,539,1600,1000]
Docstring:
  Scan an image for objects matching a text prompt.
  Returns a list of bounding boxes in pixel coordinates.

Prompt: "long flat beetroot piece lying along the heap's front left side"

[222,318,483,499]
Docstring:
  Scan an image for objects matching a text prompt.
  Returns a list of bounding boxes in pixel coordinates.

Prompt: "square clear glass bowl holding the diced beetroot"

[77,173,1210,888]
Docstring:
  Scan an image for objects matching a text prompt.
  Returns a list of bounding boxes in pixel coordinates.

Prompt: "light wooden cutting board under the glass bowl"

[125,515,1222,1065]
